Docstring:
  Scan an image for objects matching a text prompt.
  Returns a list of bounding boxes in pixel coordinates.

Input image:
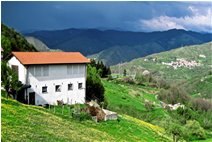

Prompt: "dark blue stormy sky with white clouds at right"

[1,1,212,33]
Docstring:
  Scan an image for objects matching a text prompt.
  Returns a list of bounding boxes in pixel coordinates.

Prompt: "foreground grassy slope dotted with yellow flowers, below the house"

[1,97,170,142]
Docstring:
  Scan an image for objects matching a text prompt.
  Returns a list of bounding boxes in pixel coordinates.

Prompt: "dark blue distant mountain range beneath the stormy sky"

[25,28,212,65]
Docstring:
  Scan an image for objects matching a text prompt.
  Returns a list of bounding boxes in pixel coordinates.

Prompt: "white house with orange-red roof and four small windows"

[8,52,90,105]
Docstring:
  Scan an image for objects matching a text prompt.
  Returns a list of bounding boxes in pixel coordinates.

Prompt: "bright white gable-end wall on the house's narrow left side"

[8,56,26,84]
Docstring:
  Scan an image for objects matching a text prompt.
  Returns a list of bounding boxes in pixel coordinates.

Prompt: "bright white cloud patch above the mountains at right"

[138,6,212,32]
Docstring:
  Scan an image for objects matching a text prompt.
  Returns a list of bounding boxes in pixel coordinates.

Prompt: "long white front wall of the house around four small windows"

[28,64,86,105]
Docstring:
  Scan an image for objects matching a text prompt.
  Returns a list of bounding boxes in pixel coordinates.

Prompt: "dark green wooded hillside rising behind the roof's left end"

[1,23,37,60]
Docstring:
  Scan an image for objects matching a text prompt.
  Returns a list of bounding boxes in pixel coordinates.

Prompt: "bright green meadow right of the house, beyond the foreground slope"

[103,81,168,124]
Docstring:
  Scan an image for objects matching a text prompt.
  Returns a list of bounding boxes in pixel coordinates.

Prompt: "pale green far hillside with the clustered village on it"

[111,42,212,97]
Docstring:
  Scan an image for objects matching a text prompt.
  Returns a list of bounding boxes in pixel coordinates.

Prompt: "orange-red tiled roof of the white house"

[12,52,90,65]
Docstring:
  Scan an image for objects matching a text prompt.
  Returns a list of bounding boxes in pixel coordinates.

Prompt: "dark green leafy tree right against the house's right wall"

[86,65,105,102]
